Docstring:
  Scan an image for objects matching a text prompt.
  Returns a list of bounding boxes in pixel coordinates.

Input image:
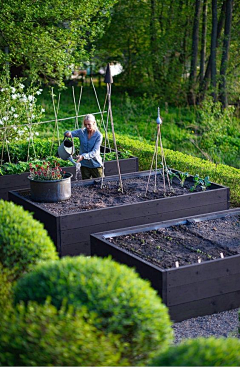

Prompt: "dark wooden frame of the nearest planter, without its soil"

[91,208,240,322]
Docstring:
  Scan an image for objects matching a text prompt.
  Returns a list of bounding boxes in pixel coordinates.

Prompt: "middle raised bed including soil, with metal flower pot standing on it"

[9,171,229,256]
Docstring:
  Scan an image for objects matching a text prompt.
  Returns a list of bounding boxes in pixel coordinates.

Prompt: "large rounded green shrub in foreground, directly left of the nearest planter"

[14,256,173,364]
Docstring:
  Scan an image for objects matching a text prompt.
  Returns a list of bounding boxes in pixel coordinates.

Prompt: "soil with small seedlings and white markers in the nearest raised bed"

[108,215,240,269]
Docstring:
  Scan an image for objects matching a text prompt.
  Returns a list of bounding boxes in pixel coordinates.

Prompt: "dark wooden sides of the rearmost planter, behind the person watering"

[0,150,138,200]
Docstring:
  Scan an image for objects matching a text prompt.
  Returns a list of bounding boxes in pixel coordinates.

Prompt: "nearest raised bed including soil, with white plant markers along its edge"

[91,208,240,322]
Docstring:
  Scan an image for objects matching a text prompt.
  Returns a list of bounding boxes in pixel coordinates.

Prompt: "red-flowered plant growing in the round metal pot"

[29,161,65,181]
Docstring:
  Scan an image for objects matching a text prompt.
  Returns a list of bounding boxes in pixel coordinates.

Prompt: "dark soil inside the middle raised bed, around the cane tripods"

[25,175,204,214]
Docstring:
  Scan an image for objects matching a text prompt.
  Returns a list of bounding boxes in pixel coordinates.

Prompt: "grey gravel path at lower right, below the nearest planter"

[173,309,240,344]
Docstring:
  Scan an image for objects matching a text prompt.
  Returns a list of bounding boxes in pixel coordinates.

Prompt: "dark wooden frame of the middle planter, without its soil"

[9,171,229,256]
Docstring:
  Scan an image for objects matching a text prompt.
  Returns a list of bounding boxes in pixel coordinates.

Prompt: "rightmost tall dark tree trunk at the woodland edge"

[219,0,233,108]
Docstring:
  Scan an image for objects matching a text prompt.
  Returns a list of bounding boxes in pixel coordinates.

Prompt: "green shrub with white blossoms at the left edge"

[0,76,44,143]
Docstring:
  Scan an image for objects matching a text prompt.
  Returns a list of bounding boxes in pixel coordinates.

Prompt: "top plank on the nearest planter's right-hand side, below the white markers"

[167,255,240,288]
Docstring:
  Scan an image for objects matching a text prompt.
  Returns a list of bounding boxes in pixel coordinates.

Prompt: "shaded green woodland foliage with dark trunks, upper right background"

[96,0,240,106]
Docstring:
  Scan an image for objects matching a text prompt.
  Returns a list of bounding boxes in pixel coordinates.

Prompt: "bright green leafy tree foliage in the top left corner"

[0,0,115,83]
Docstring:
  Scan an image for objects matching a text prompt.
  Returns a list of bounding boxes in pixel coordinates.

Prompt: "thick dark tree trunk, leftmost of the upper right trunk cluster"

[188,0,201,104]
